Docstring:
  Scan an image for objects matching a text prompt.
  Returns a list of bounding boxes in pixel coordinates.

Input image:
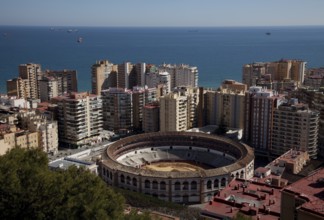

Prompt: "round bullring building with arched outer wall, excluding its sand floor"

[99,132,254,204]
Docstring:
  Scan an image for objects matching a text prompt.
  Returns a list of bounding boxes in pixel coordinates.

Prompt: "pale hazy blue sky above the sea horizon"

[0,0,324,27]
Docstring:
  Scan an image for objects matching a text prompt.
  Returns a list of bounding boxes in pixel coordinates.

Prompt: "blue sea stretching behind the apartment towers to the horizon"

[0,26,324,93]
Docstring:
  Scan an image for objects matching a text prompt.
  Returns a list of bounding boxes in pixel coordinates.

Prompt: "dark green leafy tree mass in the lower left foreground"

[0,148,126,219]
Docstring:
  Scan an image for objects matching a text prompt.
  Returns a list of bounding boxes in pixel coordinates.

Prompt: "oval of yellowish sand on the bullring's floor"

[141,162,210,172]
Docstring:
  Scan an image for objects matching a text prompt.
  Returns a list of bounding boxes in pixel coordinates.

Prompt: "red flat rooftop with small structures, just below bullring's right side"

[202,179,281,219]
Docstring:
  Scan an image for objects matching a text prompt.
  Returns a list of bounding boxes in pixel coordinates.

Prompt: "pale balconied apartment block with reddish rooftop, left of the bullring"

[52,92,103,148]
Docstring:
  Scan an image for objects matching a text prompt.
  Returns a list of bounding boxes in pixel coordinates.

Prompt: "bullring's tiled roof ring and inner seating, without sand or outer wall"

[101,132,254,178]
